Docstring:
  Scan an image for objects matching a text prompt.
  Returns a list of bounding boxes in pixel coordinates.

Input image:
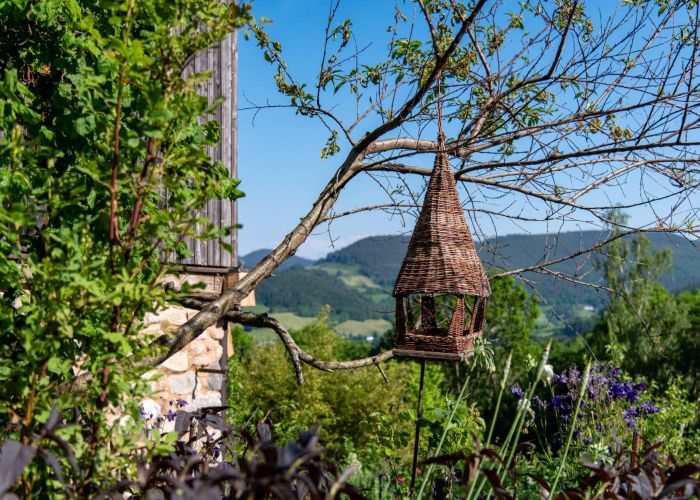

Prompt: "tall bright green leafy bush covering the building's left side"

[0,0,250,492]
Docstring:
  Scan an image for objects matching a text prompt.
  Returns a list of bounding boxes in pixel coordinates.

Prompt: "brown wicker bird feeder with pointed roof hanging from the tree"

[393,132,491,360]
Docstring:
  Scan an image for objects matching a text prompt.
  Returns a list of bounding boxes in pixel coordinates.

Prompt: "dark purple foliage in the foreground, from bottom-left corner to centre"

[0,406,363,500]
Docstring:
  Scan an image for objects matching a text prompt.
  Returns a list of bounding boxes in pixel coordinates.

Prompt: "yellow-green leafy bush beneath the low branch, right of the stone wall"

[229,315,415,460]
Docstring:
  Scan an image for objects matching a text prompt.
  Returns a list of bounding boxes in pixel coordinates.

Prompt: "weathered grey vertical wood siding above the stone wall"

[174,29,238,269]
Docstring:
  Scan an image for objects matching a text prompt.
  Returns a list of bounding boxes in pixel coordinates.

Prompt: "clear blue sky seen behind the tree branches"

[238,0,688,258]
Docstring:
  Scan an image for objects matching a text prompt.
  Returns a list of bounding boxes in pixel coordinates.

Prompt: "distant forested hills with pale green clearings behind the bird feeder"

[243,231,700,320]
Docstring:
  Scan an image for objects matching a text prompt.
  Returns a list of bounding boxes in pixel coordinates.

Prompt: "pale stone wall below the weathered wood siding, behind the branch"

[143,306,226,422]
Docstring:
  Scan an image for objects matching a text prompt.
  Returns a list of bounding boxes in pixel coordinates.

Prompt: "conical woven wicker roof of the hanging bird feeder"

[394,151,491,297]
